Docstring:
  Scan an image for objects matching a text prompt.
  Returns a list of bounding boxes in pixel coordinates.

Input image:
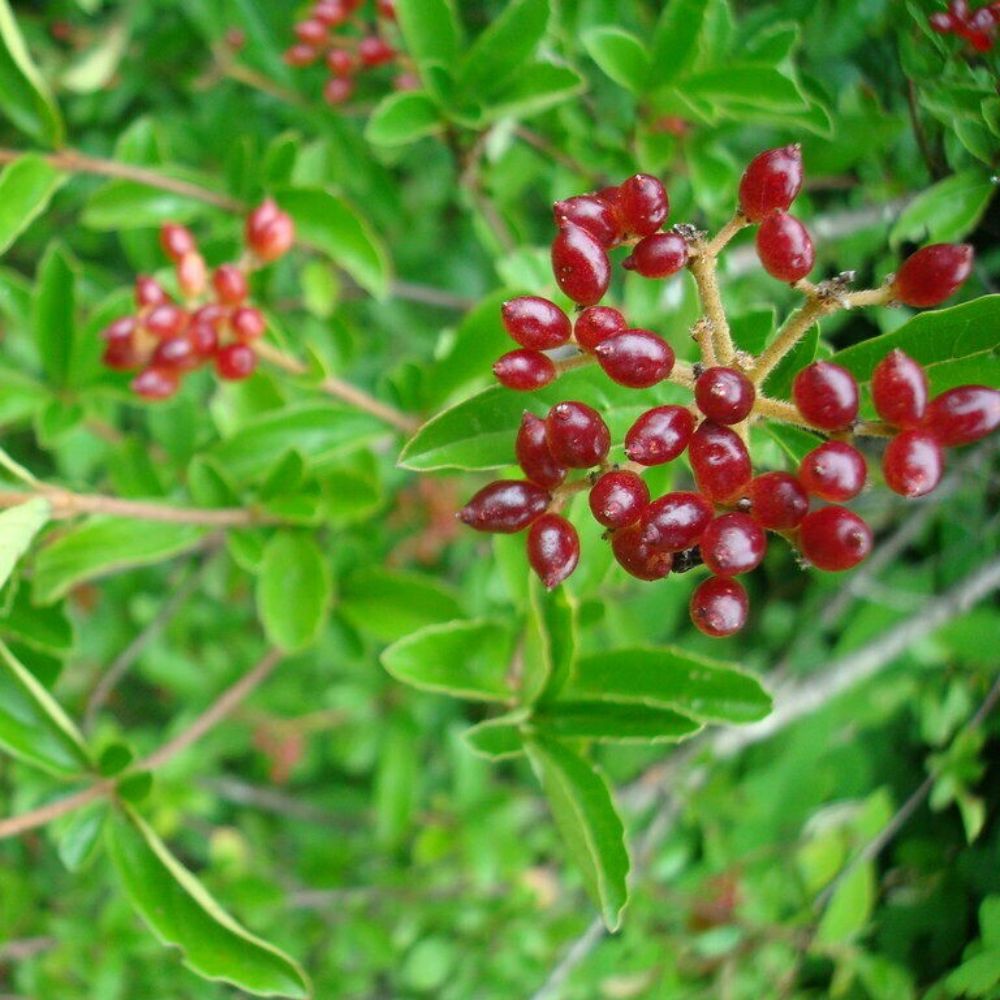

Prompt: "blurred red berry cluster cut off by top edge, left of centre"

[285,0,419,105]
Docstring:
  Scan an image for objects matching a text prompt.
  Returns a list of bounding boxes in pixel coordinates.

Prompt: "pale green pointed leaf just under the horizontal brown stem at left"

[32,517,209,604]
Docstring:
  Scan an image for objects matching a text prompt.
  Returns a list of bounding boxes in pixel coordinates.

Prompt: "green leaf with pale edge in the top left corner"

[0,0,63,147]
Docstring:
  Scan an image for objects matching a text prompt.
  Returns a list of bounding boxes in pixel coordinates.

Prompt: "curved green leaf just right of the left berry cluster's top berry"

[275,188,391,298]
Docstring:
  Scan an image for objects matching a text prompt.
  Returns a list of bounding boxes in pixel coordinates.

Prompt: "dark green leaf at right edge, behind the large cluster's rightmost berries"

[830,295,1000,392]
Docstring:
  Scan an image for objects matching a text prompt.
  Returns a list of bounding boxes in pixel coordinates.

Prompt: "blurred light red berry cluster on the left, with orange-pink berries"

[101,199,295,400]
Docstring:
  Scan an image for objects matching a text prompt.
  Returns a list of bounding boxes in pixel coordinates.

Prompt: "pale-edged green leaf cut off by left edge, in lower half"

[0,642,91,777]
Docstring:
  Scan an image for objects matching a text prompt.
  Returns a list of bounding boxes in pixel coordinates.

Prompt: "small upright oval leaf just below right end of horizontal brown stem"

[257,531,333,652]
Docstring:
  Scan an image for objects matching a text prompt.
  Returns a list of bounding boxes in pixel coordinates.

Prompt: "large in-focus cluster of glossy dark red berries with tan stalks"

[459,146,1000,636]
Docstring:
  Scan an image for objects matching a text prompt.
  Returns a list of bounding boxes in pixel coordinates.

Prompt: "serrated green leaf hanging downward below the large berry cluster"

[525,738,629,931]
